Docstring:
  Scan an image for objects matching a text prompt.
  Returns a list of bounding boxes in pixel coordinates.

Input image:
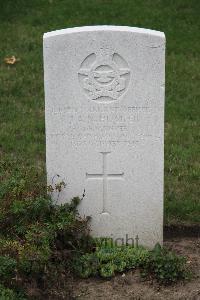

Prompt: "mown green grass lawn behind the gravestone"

[0,0,200,223]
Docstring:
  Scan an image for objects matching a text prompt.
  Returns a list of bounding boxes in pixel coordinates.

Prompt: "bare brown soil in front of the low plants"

[68,237,200,300]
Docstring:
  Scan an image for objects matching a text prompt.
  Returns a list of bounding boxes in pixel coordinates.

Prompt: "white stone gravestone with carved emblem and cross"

[44,26,165,247]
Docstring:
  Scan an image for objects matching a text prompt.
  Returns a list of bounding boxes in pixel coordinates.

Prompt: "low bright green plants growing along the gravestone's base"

[74,242,189,284]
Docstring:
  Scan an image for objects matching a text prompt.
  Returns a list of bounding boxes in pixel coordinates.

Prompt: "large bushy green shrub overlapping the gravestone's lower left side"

[0,162,90,299]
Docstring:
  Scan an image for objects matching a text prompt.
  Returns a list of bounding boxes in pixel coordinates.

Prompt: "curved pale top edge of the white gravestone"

[43,25,165,40]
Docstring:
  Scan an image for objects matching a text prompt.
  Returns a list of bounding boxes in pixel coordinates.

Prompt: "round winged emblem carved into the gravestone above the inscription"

[78,49,130,103]
